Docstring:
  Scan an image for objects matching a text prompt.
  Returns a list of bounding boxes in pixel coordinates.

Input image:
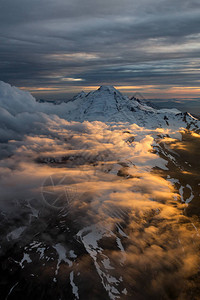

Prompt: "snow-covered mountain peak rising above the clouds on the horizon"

[55,86,200,129]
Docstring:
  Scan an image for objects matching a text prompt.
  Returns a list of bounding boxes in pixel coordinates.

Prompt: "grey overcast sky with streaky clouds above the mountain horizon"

[0,0,200,98]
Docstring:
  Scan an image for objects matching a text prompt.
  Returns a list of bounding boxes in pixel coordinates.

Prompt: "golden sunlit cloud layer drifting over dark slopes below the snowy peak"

[0,99,199,299]
